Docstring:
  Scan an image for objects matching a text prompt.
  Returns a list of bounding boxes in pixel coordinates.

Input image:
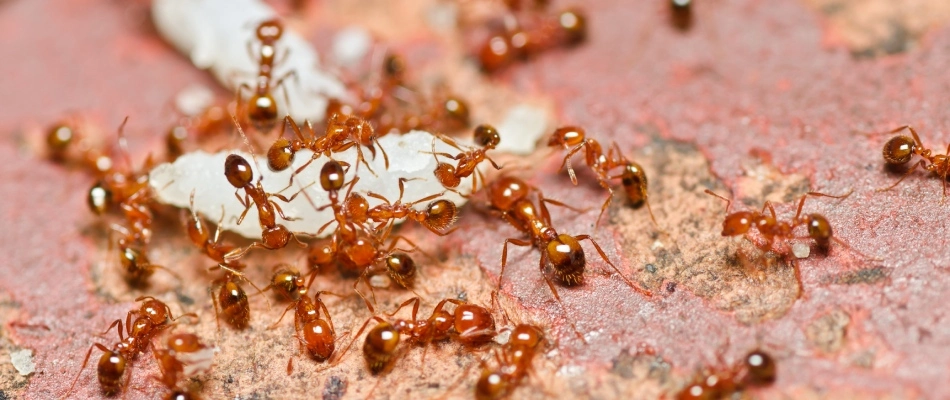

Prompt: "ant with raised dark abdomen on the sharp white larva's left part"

[224,154,307,260]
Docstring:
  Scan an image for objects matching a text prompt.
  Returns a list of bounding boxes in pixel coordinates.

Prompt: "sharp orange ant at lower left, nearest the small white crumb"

[63,296,198,398]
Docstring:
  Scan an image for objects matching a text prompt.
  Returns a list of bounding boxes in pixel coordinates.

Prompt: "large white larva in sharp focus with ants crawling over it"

[149,131,472,238]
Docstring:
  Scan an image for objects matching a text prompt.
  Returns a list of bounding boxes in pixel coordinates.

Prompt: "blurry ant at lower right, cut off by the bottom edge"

[676,350,777,400]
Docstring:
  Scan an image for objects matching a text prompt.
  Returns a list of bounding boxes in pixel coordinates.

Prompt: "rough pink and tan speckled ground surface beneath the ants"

[0,0,950,399]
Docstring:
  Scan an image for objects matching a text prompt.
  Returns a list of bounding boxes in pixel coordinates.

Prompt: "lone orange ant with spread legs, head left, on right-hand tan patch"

[706,189,867,258]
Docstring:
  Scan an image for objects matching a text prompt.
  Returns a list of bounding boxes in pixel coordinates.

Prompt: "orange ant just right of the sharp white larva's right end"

[548,126,656,225]
